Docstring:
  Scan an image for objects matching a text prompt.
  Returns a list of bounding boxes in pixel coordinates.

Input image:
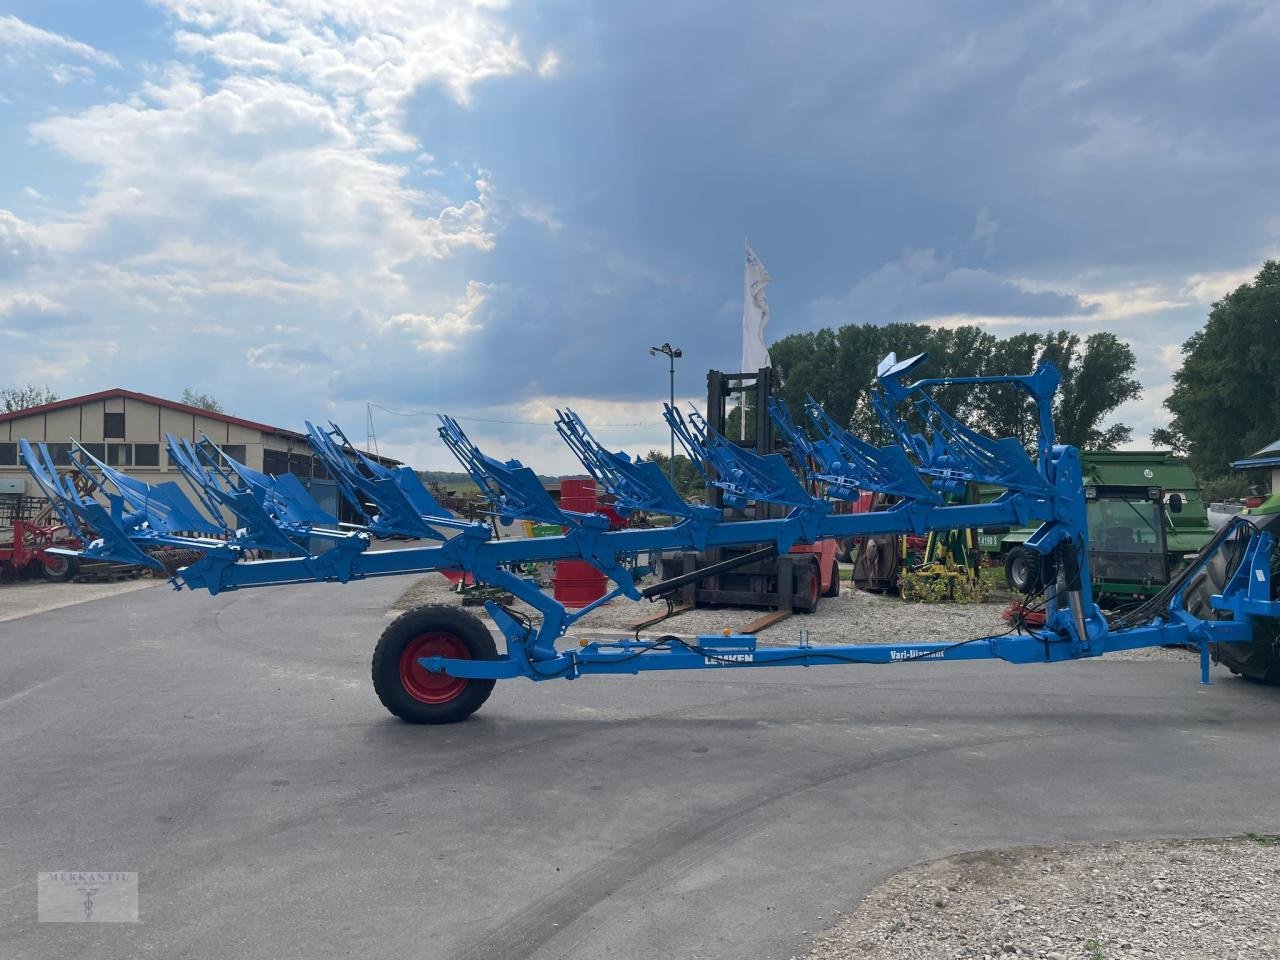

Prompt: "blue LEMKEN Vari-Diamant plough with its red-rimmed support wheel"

[20,355,1280,723]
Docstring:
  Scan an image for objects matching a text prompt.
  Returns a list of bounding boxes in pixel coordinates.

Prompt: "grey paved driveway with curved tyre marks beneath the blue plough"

[0,580,1280,960]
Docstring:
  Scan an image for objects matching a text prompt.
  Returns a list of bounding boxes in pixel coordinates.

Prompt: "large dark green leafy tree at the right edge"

[1151,260,1280,480]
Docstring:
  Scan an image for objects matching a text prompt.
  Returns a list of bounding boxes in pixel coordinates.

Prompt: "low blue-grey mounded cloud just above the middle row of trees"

[810,250,1092,326]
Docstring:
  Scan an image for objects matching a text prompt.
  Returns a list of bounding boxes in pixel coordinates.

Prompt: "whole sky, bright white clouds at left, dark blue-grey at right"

[0,0,1280,472]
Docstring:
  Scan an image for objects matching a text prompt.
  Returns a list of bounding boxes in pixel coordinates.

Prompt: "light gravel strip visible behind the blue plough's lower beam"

[393,573,1196,660]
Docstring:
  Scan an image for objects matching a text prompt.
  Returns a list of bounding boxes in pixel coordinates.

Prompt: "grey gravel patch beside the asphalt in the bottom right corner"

[808,837,1280,960]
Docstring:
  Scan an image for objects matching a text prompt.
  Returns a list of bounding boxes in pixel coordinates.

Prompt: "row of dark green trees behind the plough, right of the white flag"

[769,324,1142,449]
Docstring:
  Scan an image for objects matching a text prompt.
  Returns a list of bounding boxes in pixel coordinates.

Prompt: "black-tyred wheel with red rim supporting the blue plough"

[372,605,498,723]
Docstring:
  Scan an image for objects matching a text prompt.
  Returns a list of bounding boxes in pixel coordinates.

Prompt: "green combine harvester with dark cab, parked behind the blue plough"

[978,451,1213,604]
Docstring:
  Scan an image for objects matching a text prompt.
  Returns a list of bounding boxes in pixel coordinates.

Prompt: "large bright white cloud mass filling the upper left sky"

[0,0,524,399]
